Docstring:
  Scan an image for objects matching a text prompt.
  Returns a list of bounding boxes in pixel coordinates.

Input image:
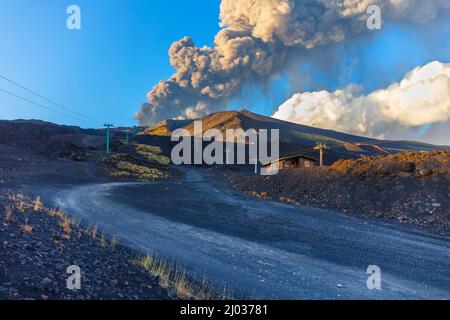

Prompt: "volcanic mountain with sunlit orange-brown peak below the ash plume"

[145,110,447,163]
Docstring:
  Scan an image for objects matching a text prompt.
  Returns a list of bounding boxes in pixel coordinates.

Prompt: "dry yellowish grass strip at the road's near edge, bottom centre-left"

[135,255,232,300]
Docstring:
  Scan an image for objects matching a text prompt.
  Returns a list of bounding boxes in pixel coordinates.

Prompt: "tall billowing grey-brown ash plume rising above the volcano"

[136,0,450,125]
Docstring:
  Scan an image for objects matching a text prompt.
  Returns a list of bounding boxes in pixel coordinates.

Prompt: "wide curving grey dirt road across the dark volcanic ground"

[44,171,450,299]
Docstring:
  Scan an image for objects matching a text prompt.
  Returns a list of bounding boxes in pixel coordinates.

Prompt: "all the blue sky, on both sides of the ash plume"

[0,0,450,127]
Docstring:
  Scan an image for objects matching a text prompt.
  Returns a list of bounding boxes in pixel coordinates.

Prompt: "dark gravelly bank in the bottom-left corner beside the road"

[0,195,170,300]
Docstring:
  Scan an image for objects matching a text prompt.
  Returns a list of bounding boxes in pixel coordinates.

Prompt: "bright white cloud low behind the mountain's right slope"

[273,61,450,144]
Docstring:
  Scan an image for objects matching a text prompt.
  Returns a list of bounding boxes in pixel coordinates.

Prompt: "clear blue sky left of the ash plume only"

[0,0,220,126]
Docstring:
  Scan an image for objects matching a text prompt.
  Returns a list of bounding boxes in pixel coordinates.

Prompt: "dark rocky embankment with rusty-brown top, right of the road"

[226,151,450,229]
